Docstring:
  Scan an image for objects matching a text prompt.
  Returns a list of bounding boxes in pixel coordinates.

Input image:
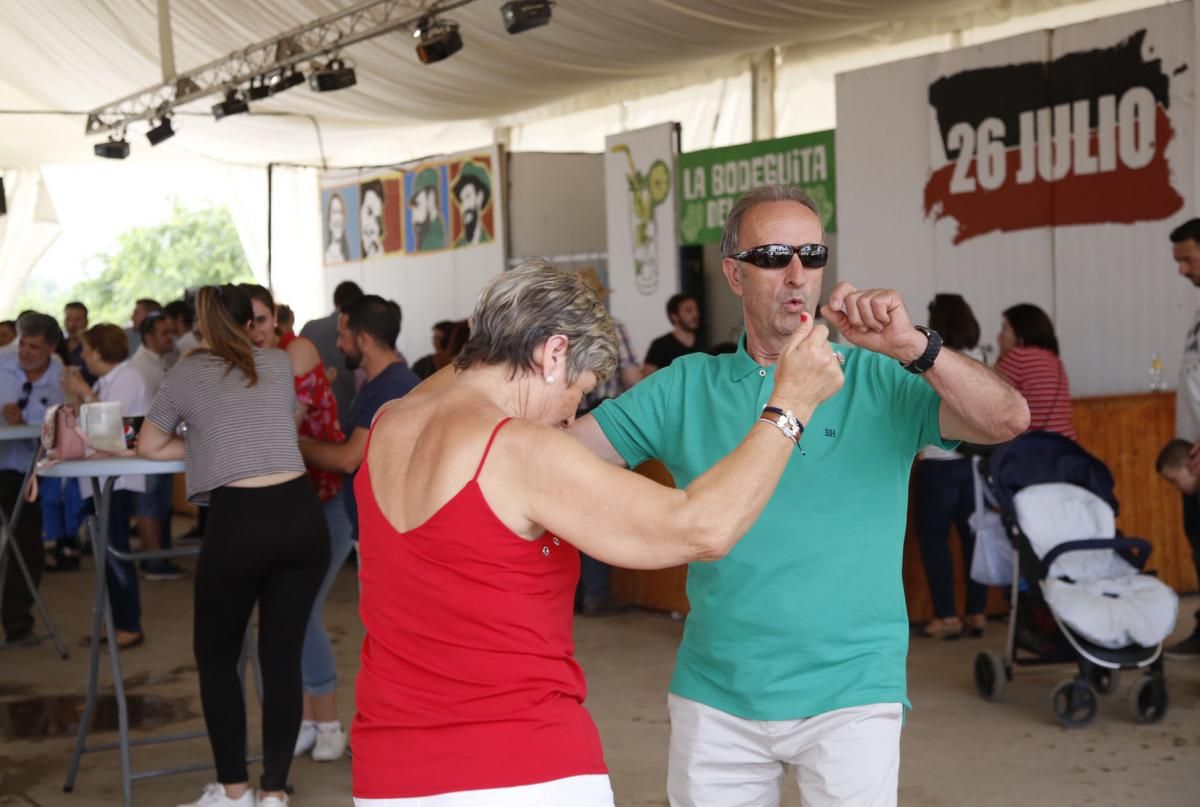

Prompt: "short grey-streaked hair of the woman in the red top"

[455,258,617,383]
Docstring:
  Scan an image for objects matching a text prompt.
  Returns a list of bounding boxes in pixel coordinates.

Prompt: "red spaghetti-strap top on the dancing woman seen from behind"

[350,419,607,799]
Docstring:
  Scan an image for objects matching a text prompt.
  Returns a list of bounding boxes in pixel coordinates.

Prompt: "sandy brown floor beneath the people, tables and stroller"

[0,547,1200,807]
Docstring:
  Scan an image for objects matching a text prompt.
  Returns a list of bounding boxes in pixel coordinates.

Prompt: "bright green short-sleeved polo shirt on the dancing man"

[593,336,954,721]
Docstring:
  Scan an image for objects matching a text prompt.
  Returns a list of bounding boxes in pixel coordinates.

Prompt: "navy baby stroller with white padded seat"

[974,431,1178,728]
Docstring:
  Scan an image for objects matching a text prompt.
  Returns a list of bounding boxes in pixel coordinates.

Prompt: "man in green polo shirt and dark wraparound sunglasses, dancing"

[574,186,1028,807]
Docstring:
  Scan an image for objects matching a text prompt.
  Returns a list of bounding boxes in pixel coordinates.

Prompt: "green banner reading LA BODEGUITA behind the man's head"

[679,128,838,244]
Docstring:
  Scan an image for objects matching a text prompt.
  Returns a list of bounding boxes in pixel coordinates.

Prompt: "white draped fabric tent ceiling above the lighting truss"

[0,0,1113,166]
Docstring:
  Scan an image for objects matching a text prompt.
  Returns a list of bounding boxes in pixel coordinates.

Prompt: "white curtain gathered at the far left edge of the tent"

[0,168,61,311]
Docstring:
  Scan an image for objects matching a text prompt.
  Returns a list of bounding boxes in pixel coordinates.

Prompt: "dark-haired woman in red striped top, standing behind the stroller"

[996,303,1079,440]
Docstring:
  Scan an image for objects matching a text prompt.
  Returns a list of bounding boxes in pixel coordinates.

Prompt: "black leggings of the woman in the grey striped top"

[193,476,329,790]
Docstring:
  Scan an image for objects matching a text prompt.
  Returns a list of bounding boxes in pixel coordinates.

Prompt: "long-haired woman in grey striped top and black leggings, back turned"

[138,286,329,807]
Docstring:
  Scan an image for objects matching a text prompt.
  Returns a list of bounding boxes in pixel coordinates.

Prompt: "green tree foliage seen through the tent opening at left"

[18,199,253,324]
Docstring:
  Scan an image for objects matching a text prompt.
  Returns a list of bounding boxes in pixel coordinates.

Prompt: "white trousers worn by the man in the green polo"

[667,695,904,807]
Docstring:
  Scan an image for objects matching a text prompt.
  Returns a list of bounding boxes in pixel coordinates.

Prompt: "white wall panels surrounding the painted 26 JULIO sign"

[836,2,1200,396]
